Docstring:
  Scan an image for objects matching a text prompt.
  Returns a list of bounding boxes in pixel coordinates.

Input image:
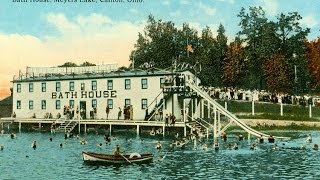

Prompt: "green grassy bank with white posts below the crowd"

[218,100,320,121]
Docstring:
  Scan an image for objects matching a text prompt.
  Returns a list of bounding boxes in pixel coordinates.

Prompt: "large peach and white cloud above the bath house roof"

[0,13,145,98]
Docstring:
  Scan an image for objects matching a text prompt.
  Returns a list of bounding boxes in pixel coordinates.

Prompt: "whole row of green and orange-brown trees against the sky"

[129,7,314,93]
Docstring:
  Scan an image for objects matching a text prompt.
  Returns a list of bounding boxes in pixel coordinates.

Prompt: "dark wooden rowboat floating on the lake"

[82,151,153,164]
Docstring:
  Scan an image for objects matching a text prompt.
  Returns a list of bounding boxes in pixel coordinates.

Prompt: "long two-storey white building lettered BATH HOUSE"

[12,64,194,120]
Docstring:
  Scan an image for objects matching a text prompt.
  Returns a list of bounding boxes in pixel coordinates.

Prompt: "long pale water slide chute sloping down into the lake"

[186,82,286,138]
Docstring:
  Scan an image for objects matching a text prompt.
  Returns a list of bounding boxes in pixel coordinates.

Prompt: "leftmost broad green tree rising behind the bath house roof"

[130,15,178,69]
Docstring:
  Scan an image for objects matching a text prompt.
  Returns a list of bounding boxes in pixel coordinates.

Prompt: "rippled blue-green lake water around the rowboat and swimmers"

[0,131,320,179]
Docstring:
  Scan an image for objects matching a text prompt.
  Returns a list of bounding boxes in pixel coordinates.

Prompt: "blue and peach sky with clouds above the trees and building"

[0,0,320,99]
